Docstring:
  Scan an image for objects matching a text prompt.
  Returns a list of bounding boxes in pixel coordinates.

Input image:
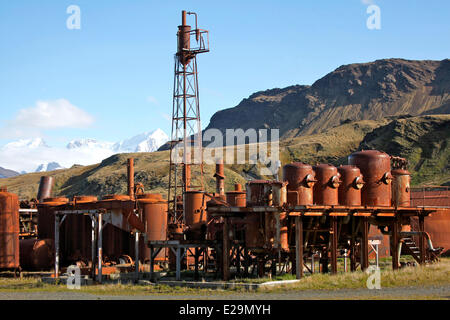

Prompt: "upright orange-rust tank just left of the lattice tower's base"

[137,193,167,262]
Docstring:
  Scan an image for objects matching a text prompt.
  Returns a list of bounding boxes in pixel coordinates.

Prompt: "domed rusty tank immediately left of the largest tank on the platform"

[338,165,364,206]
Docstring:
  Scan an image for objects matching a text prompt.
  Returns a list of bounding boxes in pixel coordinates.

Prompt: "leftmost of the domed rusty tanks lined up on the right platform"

[283,162,316,206]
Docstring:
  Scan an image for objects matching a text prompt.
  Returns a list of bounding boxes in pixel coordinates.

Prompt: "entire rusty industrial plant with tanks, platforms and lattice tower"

[0,11,450,282]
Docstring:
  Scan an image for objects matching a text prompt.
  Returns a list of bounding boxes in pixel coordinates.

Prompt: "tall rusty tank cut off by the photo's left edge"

[0,188,20,269]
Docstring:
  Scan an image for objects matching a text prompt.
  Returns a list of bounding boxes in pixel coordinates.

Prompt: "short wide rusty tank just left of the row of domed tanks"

[246,180,287,206]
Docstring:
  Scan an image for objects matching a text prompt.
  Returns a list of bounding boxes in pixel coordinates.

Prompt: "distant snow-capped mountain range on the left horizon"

[0,129,169,173]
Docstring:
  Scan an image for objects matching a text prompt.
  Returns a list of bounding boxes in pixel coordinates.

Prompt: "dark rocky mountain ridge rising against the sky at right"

[207,59,450,137]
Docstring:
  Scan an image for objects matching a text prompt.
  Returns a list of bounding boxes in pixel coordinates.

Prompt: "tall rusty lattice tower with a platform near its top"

[167,10,209,223]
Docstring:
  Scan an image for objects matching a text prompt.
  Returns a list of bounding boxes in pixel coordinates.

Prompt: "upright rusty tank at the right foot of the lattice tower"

[184,190,209,240]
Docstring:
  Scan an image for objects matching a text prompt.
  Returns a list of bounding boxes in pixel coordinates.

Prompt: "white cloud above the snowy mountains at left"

[0,99,94,139]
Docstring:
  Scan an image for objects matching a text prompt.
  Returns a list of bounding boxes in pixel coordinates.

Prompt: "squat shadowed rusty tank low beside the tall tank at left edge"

[20,239,55,271]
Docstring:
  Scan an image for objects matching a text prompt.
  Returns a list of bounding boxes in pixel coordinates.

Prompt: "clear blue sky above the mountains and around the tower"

[0,0,450,146]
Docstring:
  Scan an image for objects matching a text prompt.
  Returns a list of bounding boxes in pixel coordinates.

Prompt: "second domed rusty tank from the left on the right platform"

[313,164,341,205]
